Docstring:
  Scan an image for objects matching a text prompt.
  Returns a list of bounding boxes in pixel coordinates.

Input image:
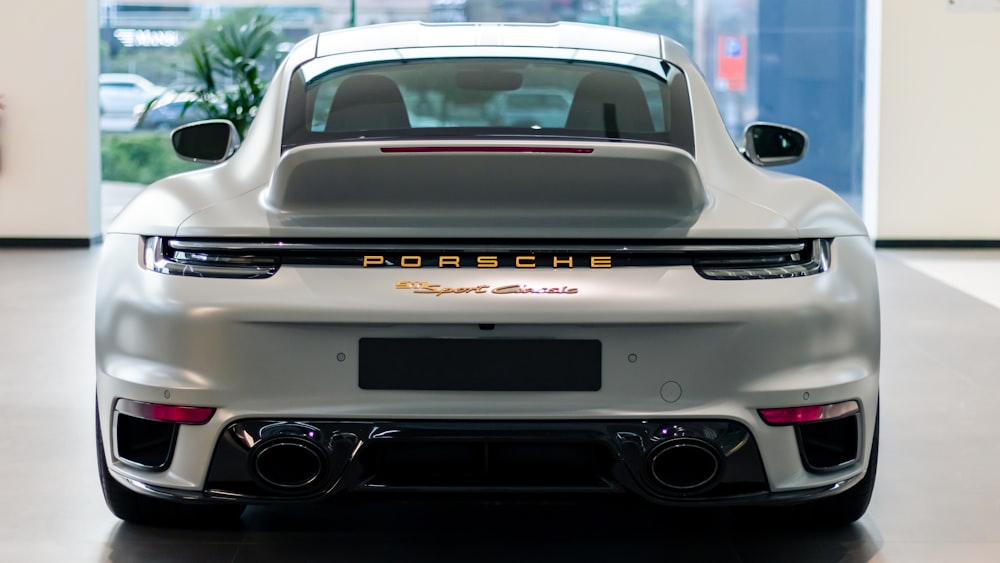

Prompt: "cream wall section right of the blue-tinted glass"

[865,0,1000,240]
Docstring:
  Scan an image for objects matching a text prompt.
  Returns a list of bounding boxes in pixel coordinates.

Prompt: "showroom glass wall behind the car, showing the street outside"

[101,0,865,211]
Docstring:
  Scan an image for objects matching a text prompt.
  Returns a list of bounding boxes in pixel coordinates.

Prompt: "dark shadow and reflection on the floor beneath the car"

[103,499,881,563]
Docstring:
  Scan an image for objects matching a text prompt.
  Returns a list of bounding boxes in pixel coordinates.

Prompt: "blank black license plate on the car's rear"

[358,338,601,391]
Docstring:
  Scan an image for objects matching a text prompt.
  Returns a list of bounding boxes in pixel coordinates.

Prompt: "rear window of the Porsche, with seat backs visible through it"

[283,58,694,153]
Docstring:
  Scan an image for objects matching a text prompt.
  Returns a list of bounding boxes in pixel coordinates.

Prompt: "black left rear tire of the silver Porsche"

[97,406,246,528]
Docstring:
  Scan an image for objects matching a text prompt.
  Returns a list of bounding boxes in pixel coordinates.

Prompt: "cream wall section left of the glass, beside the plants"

[0,0,100,243]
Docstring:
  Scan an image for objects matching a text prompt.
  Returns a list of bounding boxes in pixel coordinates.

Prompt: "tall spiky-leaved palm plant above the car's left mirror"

[161,11,278,138]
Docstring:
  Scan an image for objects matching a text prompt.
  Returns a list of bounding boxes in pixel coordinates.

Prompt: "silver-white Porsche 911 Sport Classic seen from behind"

[96,19,879,525]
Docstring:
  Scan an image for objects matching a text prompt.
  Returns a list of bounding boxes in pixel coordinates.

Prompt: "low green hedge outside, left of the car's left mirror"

[101,132,202,184]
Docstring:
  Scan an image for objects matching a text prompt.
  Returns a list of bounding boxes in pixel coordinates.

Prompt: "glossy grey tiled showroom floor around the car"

[0,250,1000,563]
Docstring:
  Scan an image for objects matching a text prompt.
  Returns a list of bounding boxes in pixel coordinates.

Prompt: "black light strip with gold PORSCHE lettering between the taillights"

[158,237,829,279]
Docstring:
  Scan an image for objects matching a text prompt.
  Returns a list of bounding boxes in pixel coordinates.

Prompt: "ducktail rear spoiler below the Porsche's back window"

[264,140,706,229]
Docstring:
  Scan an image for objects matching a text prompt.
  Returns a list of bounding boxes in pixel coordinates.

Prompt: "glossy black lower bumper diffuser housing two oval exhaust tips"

[113,420,863,506]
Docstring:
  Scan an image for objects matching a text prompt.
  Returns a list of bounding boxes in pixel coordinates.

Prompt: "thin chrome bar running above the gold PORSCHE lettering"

[170,239,806,254]
